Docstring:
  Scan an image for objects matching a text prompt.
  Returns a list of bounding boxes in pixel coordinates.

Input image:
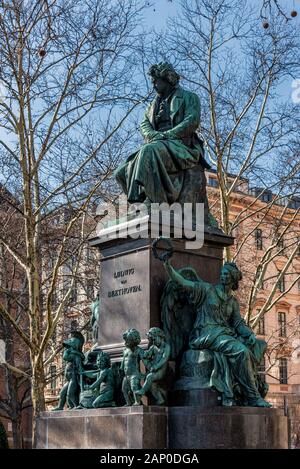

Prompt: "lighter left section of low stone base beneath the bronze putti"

[37,406,168,449]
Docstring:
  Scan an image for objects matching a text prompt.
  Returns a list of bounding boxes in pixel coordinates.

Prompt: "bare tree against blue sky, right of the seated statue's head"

[161,0,300,241]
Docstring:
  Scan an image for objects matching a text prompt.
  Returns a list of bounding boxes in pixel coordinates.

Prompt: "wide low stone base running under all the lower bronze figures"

[37,406,288,449]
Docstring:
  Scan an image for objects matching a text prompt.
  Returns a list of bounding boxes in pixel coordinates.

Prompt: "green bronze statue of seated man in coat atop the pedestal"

[115,62,209,207]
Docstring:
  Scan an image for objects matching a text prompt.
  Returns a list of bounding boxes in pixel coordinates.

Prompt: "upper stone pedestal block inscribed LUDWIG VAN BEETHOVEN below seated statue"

[90,216,233,361]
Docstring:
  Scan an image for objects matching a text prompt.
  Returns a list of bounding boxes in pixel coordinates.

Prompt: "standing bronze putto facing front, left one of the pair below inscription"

[120,329,144,406]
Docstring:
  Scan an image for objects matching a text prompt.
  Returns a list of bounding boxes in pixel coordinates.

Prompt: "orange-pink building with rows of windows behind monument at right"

[207,172,300,406]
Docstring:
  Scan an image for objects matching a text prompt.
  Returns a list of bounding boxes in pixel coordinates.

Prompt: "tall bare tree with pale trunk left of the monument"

[0,0,149,445]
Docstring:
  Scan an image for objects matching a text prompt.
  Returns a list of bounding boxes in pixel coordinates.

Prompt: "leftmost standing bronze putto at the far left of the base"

[52,331,85,411]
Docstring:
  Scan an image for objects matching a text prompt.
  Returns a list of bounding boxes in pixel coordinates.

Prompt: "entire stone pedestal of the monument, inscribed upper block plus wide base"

[37,216,287,449]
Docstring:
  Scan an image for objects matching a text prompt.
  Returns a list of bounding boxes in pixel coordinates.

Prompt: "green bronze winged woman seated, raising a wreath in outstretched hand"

[159,249,270,407]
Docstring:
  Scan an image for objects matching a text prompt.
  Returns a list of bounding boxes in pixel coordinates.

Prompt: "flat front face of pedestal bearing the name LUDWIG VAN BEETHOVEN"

[99,250,150,346]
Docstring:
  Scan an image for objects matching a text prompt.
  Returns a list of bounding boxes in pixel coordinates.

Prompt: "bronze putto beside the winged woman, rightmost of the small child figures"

[136,327,171,405]
